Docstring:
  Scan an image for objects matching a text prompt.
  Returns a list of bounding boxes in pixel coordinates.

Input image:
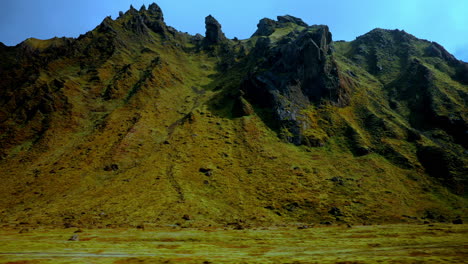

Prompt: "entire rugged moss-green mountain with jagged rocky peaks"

[0,4,468,227]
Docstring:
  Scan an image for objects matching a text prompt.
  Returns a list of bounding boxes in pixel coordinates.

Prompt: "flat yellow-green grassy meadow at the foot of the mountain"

[0,224,468,264]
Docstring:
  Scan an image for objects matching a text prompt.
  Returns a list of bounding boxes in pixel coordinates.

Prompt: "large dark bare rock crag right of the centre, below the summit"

[242,26,349,145]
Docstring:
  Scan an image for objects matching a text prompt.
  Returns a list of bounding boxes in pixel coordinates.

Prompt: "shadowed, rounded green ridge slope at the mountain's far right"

[338,29,468,194]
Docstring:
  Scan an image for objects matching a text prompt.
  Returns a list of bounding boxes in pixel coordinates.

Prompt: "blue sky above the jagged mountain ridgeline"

[0,0,468,61]
